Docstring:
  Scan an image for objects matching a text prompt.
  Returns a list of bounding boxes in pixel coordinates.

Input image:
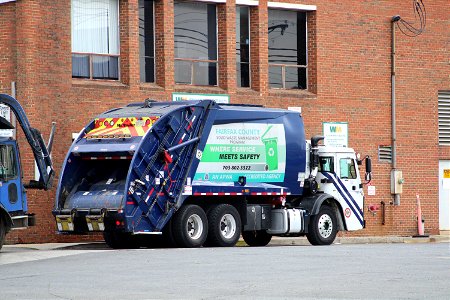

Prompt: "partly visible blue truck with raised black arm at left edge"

[0,94,56,249]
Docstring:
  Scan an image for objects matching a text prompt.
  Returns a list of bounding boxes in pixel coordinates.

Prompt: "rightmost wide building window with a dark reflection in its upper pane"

[268,9,308,89]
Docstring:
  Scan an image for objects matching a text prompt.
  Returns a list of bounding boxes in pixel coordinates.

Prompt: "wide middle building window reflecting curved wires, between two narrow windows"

[174,2,217,85]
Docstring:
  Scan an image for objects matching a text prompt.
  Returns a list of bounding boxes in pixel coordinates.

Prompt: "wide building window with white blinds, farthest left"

[71,0,119,80]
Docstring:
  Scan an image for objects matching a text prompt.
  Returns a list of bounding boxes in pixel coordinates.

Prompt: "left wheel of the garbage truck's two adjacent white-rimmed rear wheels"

[172,204,208,248]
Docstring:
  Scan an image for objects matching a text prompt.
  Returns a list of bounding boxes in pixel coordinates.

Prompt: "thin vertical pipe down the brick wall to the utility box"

[391,15,400,205]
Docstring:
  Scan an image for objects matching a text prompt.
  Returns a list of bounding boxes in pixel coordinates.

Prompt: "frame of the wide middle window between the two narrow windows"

[174,0,221,87]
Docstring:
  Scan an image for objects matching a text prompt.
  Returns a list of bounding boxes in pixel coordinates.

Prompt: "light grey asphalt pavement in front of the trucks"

[0,243,450,300]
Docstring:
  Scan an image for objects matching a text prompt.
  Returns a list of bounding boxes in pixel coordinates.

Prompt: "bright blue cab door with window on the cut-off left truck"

[0,141,27,212]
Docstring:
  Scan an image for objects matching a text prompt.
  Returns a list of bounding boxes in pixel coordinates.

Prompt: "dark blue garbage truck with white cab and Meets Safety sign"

[53,100,371,248]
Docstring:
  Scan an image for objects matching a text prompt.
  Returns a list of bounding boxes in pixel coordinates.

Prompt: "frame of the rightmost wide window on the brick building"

[267,6,310,91]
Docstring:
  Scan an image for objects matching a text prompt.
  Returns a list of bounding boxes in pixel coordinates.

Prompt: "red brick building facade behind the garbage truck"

[0,0,450,242]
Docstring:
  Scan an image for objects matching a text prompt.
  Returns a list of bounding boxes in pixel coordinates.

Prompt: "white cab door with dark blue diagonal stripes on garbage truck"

[336,153,364,228]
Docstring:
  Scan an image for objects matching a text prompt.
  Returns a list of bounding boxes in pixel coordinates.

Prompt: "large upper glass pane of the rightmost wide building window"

[268,9,306,65]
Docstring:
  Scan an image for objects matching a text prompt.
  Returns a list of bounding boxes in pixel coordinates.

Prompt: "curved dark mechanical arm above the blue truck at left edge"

[0,94,55,190]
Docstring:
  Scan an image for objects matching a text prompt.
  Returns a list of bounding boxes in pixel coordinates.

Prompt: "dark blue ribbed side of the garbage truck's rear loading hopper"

[125,100,212,233]
